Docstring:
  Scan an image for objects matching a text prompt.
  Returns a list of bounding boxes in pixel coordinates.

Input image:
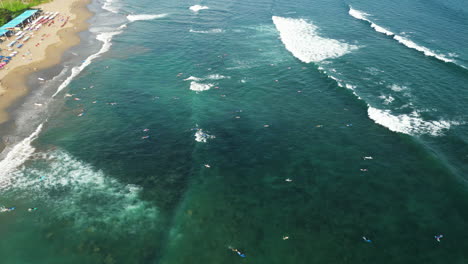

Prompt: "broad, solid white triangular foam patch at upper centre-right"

[272,16,358,63]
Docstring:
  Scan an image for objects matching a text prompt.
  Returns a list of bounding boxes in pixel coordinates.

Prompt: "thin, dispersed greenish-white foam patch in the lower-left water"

[5,150,157,232]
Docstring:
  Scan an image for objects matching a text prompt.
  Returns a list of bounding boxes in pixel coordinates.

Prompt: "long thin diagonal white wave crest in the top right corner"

[349,6,456,64]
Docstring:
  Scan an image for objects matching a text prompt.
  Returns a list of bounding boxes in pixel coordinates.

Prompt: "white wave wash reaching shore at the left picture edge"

[0,124,43,189]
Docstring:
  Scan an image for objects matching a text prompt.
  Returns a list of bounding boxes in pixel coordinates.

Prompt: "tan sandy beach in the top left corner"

[0,0,92,123]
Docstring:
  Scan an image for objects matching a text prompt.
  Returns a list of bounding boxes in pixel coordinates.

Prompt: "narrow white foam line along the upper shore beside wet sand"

[52,29,125,97]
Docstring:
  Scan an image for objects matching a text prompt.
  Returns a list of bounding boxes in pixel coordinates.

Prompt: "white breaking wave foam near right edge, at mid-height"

[367,105,460,136]
